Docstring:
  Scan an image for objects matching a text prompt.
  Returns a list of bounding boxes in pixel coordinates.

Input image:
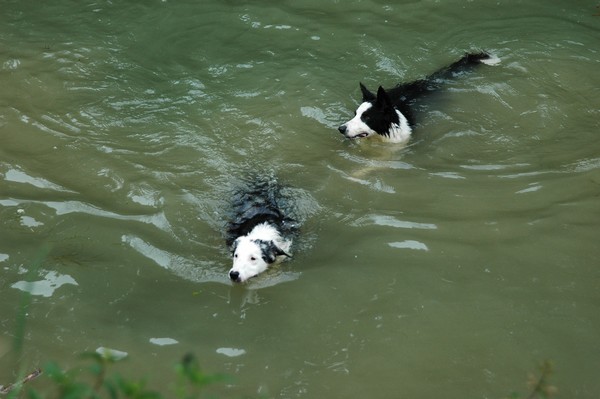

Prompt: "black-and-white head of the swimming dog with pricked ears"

[338,83,400,139]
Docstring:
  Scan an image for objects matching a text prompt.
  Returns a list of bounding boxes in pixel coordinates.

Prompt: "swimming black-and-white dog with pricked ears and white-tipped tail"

[338,52,500,143]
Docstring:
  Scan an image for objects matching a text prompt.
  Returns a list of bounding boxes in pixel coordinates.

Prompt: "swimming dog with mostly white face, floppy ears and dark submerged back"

[227,181,296,283]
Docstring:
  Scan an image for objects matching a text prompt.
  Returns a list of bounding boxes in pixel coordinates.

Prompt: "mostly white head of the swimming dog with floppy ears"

[229,236,290,283]
